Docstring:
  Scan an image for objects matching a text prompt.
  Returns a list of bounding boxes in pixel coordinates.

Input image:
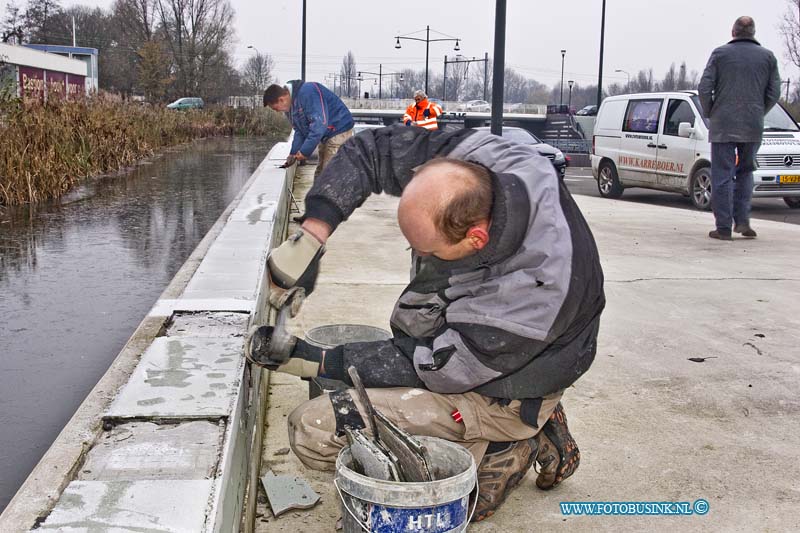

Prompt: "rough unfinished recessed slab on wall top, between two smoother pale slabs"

[76,420,225,481]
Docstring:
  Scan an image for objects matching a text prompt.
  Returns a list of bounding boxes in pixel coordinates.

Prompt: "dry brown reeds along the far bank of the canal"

[0,98,289,205]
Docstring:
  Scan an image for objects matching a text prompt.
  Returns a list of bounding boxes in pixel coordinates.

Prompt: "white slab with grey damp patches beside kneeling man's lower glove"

[106,337,243,418]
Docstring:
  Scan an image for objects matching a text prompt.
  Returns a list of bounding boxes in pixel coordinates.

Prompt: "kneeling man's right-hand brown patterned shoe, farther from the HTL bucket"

[536,402,581,490]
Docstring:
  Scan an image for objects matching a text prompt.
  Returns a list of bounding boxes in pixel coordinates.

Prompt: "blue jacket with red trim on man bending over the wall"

[287,80,353,157]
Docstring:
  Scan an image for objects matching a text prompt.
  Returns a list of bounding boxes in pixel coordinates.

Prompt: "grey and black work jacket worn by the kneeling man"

[305,126,605,399]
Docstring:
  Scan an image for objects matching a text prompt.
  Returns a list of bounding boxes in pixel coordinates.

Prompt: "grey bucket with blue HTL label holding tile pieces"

[333,437,477,533]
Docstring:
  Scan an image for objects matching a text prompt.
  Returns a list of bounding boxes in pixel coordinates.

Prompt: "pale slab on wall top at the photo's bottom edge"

[36,480,212,533]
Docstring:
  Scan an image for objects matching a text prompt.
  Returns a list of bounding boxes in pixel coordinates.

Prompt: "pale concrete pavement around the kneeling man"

[256,167,800,533]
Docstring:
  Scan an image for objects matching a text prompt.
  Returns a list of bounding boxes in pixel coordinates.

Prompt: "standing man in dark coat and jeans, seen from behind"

[699,17,781,241]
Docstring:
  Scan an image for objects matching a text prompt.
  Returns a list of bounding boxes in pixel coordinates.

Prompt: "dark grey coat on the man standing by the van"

[699,39,781,143]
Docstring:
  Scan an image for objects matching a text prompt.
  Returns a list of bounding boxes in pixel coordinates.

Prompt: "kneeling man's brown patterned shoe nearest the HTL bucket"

[472,438,539,522]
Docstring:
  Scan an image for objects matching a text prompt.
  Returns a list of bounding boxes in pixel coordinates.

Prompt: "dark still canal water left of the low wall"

[0,138,272,512]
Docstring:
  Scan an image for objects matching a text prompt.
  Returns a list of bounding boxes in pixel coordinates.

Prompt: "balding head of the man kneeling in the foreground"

[397,158,492,259]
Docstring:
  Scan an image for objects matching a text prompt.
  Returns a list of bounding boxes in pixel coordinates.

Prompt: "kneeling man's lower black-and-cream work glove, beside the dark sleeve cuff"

[244,326,323,378]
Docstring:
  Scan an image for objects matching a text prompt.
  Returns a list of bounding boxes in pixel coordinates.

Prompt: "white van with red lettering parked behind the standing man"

[591,91,800,209]
